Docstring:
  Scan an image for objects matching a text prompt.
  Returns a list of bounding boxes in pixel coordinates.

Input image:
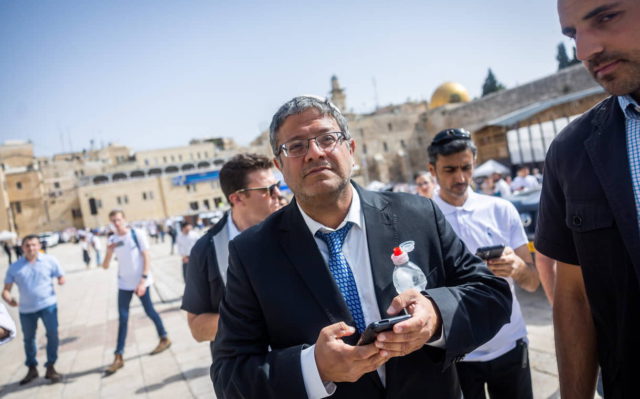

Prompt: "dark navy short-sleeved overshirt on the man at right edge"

[536,97,640,398]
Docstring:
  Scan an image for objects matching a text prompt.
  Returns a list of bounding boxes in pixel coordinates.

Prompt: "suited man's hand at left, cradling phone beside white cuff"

[315,322,389,383]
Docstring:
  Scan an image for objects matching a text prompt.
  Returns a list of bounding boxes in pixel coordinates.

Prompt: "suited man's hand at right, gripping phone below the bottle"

[375,289,442,357]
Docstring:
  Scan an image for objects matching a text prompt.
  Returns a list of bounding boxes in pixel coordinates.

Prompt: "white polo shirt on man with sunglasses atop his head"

[433,190,528,362]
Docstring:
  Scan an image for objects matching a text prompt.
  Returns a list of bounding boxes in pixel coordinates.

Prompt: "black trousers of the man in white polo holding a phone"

[456,339,533,399]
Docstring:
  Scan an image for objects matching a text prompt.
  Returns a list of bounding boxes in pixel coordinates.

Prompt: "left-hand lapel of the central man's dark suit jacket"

[280,200,357,335]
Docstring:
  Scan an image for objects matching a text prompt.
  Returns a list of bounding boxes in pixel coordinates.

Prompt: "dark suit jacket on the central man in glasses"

[211,188,511,398]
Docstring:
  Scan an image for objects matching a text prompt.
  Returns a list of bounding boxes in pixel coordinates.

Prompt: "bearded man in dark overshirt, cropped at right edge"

[536,0,640,398]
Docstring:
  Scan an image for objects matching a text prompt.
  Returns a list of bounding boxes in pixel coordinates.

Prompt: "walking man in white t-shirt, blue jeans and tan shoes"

[102,209,171,375]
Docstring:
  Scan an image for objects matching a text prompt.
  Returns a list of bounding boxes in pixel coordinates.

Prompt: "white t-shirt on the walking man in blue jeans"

[108,229,153,291]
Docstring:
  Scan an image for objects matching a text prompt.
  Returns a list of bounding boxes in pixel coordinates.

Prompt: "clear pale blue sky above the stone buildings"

[0,0,571,156]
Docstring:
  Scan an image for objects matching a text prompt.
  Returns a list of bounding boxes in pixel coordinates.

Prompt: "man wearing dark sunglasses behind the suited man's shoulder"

[181,154,280,348]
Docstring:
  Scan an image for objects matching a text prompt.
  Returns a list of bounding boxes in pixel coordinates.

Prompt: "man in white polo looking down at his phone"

[427,129,540,399]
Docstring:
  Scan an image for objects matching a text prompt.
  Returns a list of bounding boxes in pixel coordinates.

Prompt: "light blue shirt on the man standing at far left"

[4,254,64,313]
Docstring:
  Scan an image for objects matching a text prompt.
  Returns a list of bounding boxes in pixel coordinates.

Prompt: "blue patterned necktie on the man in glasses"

[316,222,366,333]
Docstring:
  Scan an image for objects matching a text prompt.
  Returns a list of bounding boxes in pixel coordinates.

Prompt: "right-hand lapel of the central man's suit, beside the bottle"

[356,186,399,318]
